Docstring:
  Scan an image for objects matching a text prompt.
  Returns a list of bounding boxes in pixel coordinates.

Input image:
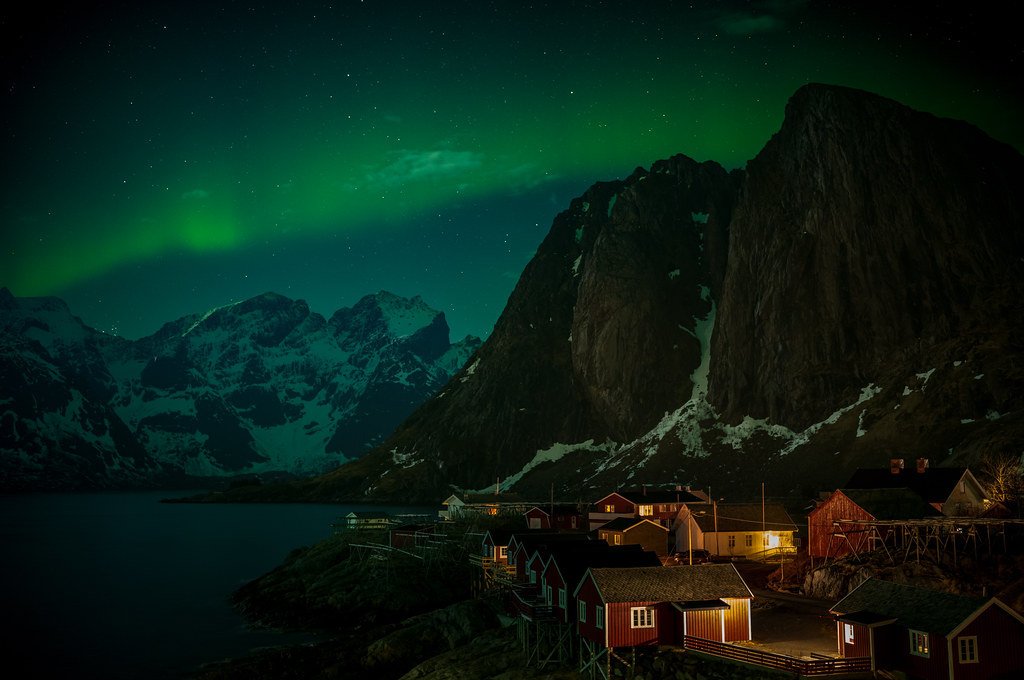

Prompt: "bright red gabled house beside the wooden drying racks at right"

[807,488,940,557]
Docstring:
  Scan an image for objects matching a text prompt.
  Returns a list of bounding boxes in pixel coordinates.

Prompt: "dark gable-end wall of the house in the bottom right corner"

[951,605,1024,680]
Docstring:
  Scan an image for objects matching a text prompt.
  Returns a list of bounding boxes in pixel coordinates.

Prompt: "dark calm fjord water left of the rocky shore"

[0,492,424,679]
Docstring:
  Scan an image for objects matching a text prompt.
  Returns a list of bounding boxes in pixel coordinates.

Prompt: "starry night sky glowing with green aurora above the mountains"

[0,0,1024,338]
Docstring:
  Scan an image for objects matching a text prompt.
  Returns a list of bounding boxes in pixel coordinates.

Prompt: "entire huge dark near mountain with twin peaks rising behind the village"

[311,85,1024,502]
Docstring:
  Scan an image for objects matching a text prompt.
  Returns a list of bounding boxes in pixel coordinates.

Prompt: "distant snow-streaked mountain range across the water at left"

[0,289,479,490]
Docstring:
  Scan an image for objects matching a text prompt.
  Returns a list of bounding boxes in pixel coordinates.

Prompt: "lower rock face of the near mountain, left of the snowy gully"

[324,156,736,495]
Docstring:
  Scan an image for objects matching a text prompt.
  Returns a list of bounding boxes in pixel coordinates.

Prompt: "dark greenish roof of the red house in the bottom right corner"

[830,579,985,635]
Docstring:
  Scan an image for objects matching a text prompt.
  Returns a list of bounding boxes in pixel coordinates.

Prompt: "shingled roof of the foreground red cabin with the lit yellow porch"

[577,564,753,604]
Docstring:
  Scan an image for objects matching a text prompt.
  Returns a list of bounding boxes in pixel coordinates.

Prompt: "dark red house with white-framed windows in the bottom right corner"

[831,579,1024,680]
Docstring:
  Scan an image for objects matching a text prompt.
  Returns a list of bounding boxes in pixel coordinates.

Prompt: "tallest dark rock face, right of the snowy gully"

[710,86,1024,428]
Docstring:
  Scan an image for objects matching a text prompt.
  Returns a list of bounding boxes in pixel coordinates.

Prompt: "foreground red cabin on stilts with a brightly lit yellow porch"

[573,564,754,648]
